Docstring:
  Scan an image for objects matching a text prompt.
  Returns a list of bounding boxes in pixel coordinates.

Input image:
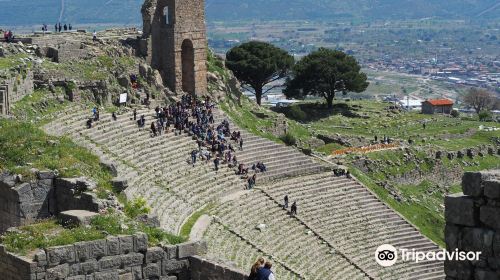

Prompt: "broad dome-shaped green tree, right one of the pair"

[284,48,369,109]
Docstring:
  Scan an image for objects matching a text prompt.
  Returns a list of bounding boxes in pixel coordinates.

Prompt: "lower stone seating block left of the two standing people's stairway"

[207,191,368,279]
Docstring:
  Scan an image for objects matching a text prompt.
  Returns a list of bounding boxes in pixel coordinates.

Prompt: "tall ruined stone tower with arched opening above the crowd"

[141,0,207,94]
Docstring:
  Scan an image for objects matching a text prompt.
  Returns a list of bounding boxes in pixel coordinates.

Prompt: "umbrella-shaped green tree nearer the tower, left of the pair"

[226,41,294,105]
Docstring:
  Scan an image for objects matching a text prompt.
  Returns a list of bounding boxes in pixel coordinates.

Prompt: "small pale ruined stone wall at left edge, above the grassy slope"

[0,67,34,115]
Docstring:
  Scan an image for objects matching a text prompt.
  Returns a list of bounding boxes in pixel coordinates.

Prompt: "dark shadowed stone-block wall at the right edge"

[445,170,500,280]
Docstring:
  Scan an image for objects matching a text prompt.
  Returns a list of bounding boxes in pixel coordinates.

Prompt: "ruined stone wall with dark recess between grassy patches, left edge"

[0,171,118,233]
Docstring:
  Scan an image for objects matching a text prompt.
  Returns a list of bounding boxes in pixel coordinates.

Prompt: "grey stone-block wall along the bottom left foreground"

[0,236,246,280]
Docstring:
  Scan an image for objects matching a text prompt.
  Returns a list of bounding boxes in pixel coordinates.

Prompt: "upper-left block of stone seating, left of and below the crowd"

[44,105,244,232]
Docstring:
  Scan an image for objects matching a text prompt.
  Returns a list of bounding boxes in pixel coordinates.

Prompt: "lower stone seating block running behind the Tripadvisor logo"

[264,172,443,279]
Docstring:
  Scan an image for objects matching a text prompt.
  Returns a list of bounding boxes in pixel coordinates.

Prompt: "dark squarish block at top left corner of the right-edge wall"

[444,193,479,226]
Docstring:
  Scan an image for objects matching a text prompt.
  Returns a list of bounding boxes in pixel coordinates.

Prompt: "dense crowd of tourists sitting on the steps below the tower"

[143,95,267,189]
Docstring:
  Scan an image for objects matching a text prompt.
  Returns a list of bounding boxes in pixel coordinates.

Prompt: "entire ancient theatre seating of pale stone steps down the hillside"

[45,105,444,279]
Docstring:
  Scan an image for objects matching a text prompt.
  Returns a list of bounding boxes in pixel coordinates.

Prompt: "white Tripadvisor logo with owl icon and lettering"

[375,244,481,267]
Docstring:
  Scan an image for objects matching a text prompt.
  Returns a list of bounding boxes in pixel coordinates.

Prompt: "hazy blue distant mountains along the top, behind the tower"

[0,0,500,26]
